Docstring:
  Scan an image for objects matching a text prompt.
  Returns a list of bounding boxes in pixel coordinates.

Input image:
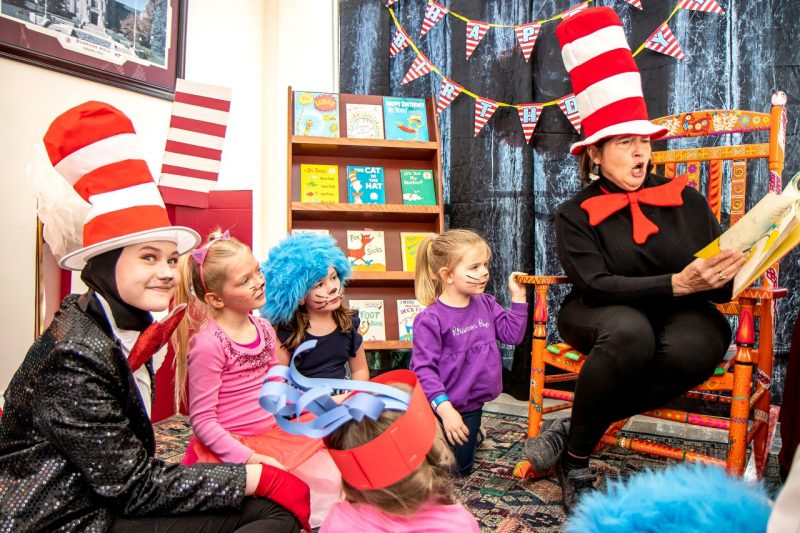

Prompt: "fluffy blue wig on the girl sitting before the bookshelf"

[261,233,350,324]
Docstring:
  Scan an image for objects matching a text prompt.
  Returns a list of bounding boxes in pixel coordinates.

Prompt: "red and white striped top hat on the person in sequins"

[44,102,200,270]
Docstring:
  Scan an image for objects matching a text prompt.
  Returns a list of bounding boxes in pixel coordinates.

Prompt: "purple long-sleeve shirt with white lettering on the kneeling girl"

[410,294,528,413]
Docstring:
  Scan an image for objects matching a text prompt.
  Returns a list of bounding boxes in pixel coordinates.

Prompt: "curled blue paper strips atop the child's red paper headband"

[258,340,411,439]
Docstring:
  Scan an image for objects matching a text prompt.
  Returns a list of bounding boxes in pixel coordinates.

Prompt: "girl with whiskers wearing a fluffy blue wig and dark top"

[261,233,369,380]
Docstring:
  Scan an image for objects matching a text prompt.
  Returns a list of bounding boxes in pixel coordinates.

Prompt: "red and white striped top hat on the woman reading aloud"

[556,7,667,155]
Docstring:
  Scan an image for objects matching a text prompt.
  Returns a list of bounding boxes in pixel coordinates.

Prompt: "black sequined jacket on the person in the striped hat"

[0,295,245,533]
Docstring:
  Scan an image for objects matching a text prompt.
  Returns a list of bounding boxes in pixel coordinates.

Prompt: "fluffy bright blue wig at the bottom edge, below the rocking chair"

[567,463,770,533]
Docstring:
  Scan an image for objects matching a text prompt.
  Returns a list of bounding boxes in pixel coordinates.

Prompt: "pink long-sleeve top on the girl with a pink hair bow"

[188,317,277,463]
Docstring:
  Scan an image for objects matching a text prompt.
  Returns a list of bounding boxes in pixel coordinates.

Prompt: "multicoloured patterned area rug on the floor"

[155,413,780,533]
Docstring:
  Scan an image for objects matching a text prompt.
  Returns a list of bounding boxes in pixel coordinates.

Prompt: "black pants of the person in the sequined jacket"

[109,497,300,533]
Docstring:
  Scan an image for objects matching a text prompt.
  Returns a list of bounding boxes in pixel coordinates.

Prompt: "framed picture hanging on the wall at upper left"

[0,0,188,100]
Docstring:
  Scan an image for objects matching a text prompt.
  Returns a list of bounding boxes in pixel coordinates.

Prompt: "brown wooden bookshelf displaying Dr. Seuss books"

[287,87,444,350]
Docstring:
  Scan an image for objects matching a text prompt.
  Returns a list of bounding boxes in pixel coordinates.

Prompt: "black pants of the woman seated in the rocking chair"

[558,299,731,456]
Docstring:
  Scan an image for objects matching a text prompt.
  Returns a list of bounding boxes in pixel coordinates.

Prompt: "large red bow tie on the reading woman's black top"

[581,174,688,244]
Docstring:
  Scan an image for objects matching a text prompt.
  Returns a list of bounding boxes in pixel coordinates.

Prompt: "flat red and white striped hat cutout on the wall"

[158,79,231,207]
